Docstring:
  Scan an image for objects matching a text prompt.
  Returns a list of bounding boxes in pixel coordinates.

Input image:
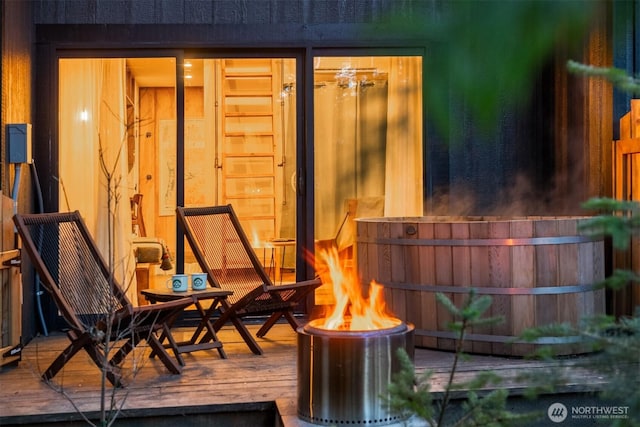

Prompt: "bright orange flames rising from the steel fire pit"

[316,248,401,331]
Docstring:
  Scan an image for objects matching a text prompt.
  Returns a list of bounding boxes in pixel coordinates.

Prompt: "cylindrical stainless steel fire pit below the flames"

[297,321,414,426]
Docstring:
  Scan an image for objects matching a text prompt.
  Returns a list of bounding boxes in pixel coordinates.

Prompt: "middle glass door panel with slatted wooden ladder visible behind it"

[184,58,296,281]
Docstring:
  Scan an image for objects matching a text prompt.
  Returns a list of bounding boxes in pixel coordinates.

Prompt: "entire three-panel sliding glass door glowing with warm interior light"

[56,56,423,308]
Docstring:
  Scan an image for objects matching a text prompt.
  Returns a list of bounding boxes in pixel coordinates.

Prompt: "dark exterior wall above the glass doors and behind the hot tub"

[34,0,612,214]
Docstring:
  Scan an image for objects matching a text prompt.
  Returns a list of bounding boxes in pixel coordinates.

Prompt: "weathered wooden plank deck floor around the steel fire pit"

[0,324,602,426]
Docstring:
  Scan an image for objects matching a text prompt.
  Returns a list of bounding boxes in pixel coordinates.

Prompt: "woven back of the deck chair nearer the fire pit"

[177,205,295,304]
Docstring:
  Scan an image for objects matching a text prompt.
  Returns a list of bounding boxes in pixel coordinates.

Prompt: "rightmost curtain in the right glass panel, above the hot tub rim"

[384,57,423,217]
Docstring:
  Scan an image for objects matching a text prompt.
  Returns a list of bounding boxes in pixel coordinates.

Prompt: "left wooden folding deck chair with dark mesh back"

[13,211,193,386]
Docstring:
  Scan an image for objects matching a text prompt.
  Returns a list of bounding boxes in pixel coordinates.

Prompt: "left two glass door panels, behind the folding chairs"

[59,58,297,300]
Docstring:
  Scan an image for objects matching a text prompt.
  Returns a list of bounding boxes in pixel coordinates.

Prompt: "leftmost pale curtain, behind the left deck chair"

[59,59,137,304]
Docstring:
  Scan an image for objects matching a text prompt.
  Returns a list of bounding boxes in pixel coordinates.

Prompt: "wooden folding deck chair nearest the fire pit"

[176,205,321,354]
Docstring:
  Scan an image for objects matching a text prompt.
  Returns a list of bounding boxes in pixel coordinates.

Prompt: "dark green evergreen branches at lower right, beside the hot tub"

[522,198,640,427]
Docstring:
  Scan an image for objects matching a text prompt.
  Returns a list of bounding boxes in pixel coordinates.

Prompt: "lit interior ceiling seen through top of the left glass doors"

[127,58,203,87]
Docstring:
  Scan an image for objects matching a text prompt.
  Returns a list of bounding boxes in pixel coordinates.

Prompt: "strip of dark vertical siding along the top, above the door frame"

[34,0,441,25]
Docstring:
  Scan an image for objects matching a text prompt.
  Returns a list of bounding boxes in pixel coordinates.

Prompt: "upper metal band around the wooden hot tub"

[358,236,602,246]
